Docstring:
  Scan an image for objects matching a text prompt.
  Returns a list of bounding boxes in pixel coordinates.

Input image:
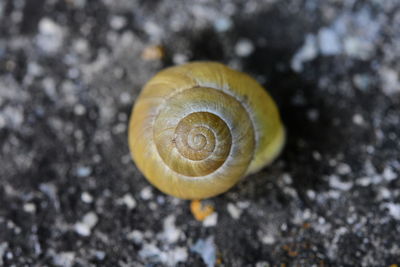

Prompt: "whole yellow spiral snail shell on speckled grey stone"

[128,62,285,199]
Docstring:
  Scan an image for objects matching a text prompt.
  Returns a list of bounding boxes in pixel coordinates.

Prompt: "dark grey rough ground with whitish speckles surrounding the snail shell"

[0,0,400,267]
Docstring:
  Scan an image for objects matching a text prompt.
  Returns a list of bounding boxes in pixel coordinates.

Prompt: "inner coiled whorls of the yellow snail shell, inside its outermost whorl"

[154,87,254,179]
